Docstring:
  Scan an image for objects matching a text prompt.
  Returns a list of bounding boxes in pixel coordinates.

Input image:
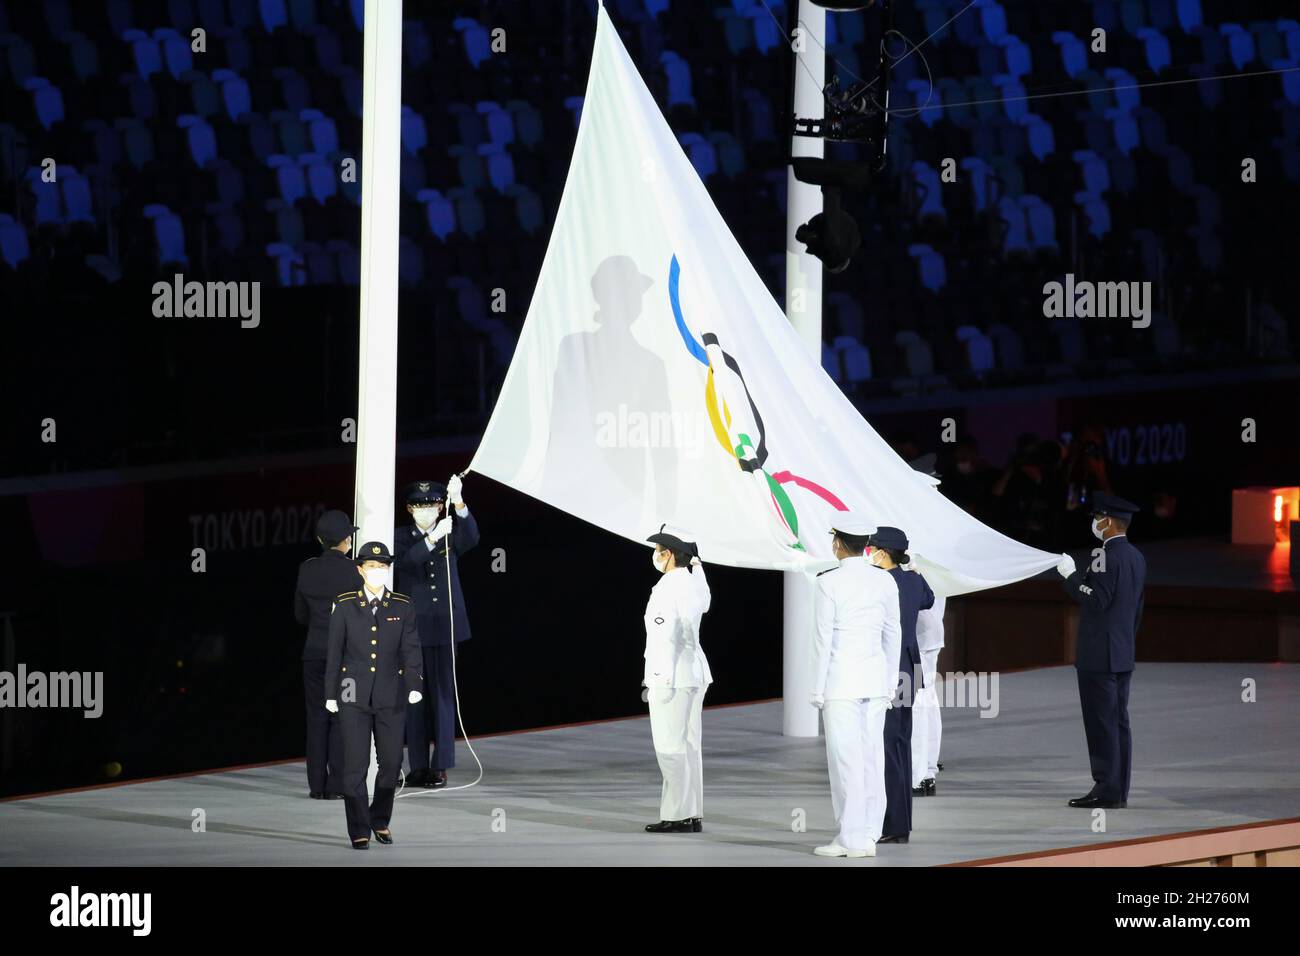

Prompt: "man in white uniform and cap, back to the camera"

[813,511,902,857]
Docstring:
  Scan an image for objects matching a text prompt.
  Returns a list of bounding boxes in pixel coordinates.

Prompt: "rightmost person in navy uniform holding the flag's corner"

[1057,493,1147,809]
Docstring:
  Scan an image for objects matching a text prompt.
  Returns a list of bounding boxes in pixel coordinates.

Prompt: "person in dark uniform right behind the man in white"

[868,525,935,843]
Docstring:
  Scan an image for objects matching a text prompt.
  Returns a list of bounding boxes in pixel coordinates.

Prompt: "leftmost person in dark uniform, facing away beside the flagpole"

[294,511,361,800]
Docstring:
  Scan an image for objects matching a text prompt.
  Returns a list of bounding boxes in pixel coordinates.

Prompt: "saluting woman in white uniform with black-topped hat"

[642,525,714,834]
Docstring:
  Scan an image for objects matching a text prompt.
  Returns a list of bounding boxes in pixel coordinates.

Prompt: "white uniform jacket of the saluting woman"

[645,564,714,687]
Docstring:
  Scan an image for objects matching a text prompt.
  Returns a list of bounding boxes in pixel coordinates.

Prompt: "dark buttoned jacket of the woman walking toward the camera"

[325,588,424,708]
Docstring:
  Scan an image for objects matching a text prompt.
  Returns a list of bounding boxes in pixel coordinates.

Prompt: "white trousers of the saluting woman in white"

[649,687,709,819]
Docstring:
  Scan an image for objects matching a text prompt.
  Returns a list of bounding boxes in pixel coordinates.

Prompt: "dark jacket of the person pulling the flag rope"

[393,511,478,646]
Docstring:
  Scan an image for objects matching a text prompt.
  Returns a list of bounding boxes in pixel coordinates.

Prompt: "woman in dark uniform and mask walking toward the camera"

[325,541,424,849]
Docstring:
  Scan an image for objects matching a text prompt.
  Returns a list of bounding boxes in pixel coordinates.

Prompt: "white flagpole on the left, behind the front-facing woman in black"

[352,0,402,792]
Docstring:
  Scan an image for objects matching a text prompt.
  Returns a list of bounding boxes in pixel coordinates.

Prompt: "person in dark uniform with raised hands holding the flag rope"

[393,475,478,790]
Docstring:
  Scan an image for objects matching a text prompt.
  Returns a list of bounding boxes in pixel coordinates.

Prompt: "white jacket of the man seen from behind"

[813,557,902,700]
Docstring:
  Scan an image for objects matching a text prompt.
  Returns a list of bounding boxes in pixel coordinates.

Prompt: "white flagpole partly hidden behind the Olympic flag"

[781,0,826,737]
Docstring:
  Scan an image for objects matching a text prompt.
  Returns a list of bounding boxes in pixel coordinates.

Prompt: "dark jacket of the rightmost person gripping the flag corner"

[1063,536,1147,674]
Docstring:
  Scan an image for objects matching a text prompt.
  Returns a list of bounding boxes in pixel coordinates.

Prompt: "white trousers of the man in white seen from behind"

[822,697,889,849]
